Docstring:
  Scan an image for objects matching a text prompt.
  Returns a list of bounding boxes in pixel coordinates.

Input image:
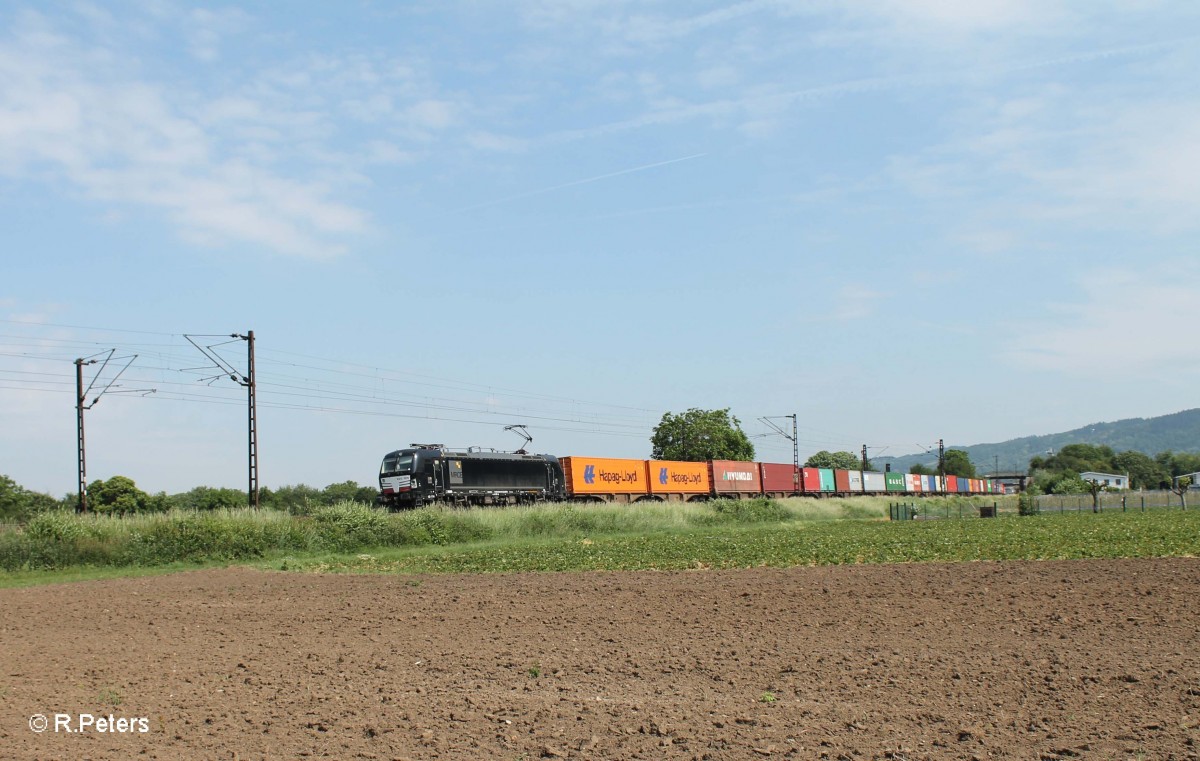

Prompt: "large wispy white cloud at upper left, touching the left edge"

[0,11,367,257]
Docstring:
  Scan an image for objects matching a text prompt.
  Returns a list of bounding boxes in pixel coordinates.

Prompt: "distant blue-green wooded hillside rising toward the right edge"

[875,409,1200,473]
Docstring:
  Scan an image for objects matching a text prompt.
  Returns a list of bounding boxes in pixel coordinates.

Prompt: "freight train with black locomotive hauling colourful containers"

[379,444,1001,509]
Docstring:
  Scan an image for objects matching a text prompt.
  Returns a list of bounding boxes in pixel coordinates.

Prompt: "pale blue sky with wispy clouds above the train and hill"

[0,0,1200,495]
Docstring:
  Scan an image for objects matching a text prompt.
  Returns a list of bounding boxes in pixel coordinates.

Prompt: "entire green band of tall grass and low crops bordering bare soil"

[0,498,1200,586]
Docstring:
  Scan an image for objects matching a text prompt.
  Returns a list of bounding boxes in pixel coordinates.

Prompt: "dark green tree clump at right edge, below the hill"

[1030,444,1200,495]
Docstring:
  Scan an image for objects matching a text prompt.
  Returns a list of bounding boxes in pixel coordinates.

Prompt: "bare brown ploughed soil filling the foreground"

[0,558,1200,760]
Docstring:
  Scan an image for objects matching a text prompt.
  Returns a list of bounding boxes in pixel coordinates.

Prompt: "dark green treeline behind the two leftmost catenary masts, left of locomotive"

[0,475,379,523]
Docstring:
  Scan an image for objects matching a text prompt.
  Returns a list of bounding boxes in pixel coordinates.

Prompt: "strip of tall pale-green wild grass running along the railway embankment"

[0,497,993,571]
